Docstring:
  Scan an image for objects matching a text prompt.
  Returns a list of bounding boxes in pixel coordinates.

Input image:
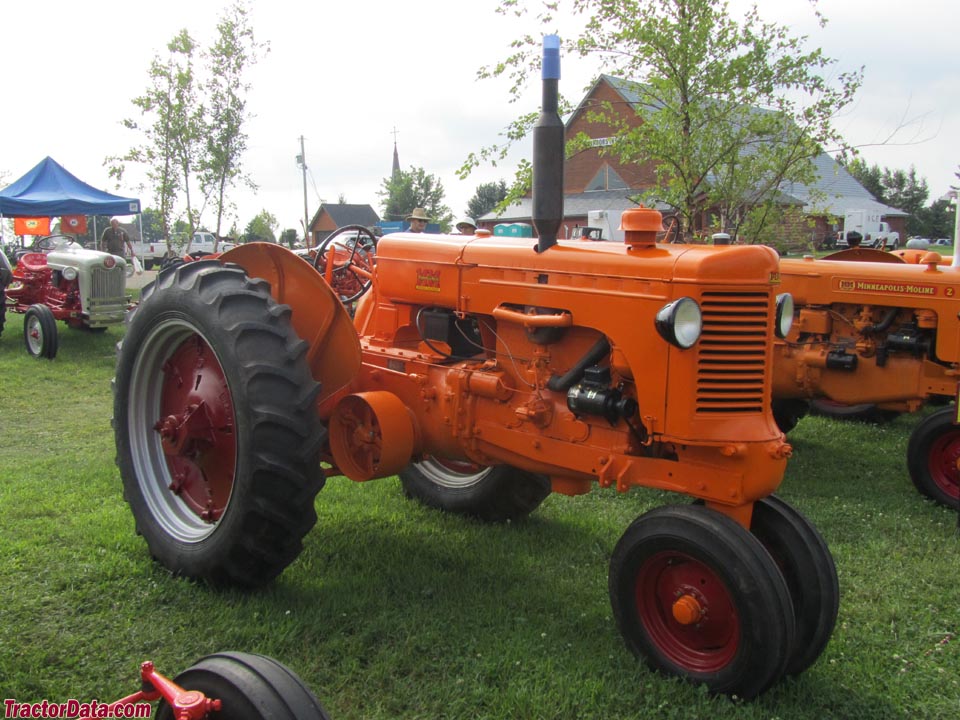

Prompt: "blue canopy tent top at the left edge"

[0,157,140,248]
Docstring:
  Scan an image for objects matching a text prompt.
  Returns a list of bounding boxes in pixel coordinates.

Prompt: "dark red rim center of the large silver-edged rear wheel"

[154,335,237,523]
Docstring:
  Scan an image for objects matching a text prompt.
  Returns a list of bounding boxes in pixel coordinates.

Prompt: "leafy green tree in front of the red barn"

[470,0,862,238]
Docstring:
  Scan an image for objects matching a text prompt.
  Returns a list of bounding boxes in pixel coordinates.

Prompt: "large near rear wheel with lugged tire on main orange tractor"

[113,260,325,587]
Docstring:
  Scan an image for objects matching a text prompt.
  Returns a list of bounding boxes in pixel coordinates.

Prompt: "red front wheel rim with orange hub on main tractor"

[635,552,740,673]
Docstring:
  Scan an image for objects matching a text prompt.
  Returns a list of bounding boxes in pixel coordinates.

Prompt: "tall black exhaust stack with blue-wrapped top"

[533,35,564,252]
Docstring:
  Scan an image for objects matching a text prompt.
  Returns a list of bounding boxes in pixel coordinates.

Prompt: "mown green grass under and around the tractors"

[0,315,960,720]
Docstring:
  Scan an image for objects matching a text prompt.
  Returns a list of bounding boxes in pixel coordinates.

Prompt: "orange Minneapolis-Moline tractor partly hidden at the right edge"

[773,248,960,508]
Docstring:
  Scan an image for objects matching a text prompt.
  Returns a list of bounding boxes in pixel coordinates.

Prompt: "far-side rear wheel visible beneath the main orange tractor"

[400,457,550,522]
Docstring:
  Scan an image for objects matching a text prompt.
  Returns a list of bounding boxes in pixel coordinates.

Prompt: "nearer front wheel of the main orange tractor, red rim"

[609,505,795,699]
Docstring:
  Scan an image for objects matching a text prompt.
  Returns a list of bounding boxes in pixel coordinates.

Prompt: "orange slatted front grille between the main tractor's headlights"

[696,292,770,413]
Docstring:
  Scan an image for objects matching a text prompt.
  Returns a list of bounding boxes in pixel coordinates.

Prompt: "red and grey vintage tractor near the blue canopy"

[0,235,130,359]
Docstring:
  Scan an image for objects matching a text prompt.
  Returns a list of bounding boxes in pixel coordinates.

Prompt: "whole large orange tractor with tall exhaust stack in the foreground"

[113,36,839,697]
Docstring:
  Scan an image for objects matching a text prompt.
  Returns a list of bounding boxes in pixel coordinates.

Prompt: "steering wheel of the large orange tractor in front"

[313,225,377,304]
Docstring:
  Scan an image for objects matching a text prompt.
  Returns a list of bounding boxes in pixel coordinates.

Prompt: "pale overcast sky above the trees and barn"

[0,0,960,233]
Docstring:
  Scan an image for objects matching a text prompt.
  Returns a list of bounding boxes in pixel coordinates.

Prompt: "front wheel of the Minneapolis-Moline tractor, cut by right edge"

[907,405,960,510]
